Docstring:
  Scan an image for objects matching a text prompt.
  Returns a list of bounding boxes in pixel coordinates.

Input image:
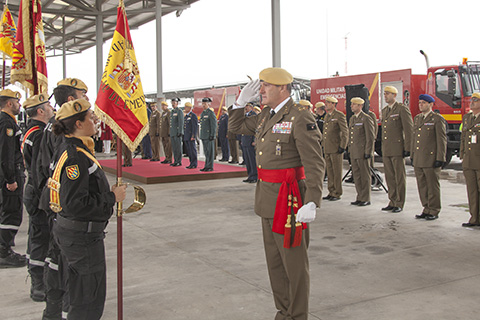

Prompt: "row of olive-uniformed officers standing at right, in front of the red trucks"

[300,86,480,227]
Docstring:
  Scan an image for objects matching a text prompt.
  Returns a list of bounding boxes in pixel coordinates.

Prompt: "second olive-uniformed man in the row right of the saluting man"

[348,97,375,207]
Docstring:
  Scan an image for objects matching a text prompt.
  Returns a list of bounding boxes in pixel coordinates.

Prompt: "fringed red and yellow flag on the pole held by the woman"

[95,1,148,151]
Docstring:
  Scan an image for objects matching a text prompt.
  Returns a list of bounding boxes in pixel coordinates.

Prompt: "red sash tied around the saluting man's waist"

[257,166,307,247]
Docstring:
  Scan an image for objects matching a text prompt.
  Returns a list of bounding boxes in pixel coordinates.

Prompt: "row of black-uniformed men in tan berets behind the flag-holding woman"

[0,78,88,320]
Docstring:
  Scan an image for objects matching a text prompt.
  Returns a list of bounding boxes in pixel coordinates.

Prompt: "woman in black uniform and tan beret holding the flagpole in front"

[49,99,126,320]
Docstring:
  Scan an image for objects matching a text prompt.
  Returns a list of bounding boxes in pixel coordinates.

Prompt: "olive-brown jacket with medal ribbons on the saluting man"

[228,98,325,218]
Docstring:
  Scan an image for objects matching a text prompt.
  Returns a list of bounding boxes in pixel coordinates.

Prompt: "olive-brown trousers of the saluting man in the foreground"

[262,218,310,320]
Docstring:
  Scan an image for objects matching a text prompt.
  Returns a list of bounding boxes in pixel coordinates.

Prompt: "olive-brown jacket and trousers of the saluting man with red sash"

[228,98,325,320]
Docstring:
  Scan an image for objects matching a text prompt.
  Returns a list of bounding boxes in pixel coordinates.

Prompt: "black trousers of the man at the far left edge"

[0,171,25,248]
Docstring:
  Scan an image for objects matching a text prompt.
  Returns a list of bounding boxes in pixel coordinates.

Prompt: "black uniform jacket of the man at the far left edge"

[0,111,25,182]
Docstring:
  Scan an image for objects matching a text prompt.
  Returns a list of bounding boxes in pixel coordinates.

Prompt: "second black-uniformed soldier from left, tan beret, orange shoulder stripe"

[22,93,53,302]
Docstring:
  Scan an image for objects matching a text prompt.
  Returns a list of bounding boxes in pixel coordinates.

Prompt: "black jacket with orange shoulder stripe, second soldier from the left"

[22,119,45,199]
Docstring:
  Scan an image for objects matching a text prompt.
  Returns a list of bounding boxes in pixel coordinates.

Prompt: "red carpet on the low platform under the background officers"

[99,158,247,184]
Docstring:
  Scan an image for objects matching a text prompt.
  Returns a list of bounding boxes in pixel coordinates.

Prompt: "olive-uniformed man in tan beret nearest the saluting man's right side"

[322,97,348,201]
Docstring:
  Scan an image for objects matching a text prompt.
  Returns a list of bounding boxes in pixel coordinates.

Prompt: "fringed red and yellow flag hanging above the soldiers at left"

[11,0,48,95]
